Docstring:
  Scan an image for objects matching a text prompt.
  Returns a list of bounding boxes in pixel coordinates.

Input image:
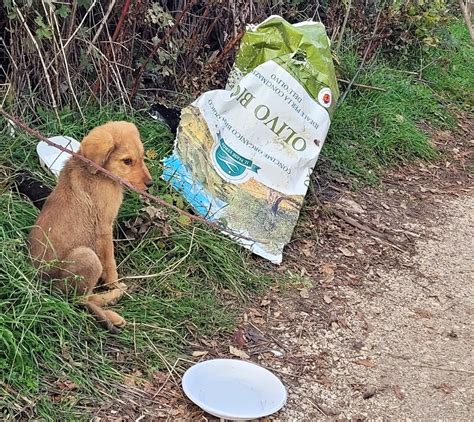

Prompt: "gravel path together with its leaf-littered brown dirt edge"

[96,117,474,421]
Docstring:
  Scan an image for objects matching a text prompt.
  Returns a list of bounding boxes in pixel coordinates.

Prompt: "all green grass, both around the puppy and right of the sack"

[0,18,474,420]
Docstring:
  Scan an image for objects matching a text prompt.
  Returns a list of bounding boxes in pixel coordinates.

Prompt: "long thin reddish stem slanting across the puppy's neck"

[0,108,243,240]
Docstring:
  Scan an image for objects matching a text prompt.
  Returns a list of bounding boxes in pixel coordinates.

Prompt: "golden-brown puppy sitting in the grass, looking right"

[29,122,152,333]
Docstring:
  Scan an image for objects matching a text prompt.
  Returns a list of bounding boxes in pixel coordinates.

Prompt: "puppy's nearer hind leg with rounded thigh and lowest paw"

[55,247,125,334]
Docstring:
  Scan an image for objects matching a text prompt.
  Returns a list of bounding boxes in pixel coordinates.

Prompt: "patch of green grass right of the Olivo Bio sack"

[322,22,474,183]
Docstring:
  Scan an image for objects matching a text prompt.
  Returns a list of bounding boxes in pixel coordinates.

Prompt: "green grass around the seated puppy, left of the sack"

[0,110,266,420]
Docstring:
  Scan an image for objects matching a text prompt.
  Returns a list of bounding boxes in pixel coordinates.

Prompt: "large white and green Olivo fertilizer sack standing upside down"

[163,16,339,263]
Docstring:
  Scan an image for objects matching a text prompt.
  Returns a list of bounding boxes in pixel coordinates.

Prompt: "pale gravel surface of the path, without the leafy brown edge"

[278,196,474,420]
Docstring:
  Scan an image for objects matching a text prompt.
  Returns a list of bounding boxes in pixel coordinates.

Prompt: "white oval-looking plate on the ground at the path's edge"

[183,359,287,420]
